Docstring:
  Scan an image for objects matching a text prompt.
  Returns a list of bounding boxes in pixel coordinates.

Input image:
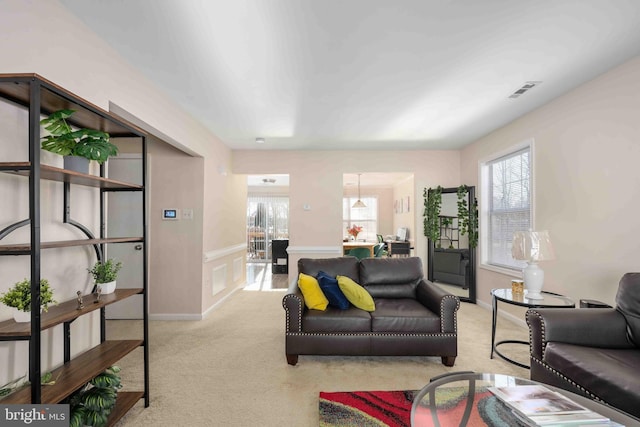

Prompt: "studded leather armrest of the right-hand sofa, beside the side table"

[526,308,634,360]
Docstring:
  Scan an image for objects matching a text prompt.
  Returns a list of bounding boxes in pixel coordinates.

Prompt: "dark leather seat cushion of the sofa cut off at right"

[544,342,640,414]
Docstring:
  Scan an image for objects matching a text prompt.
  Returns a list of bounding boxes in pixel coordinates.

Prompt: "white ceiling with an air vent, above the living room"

[60,0,640,150]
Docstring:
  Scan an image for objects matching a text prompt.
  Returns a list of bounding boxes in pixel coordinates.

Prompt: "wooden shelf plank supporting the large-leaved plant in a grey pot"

[0,162,142,190]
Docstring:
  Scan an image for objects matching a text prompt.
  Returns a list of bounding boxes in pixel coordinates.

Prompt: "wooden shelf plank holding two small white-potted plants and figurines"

[0,288,142,338]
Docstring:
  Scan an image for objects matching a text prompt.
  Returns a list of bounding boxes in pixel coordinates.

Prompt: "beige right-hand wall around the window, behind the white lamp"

[461,58,640,310]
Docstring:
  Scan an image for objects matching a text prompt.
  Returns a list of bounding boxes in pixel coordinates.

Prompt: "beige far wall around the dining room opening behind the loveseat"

[233,150,460,279]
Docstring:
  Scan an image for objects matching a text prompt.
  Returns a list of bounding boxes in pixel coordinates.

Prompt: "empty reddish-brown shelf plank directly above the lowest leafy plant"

[0,340,143,405]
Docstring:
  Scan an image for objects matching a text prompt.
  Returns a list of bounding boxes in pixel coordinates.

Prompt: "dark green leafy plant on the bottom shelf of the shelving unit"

[69,366,122,427]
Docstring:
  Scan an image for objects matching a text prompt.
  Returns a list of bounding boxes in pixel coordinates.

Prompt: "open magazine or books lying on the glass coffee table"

[489,385,620,426]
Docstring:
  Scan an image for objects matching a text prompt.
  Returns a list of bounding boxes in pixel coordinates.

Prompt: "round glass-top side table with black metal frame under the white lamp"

[489,288,576,369]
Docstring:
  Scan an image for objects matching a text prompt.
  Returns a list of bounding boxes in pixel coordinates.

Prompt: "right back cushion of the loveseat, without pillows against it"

[359,257,424,298]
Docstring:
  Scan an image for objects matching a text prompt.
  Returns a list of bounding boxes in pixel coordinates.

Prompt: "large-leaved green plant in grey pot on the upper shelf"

[40,110,118,164]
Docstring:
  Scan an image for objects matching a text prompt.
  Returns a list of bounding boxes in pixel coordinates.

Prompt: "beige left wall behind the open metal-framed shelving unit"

[0,0,246,384]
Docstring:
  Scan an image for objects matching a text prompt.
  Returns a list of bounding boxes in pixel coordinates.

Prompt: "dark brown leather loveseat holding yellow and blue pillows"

[282,257,460,366]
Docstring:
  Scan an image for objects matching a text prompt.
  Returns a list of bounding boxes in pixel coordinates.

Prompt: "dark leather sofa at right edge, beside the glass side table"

[526,273,640,425]
